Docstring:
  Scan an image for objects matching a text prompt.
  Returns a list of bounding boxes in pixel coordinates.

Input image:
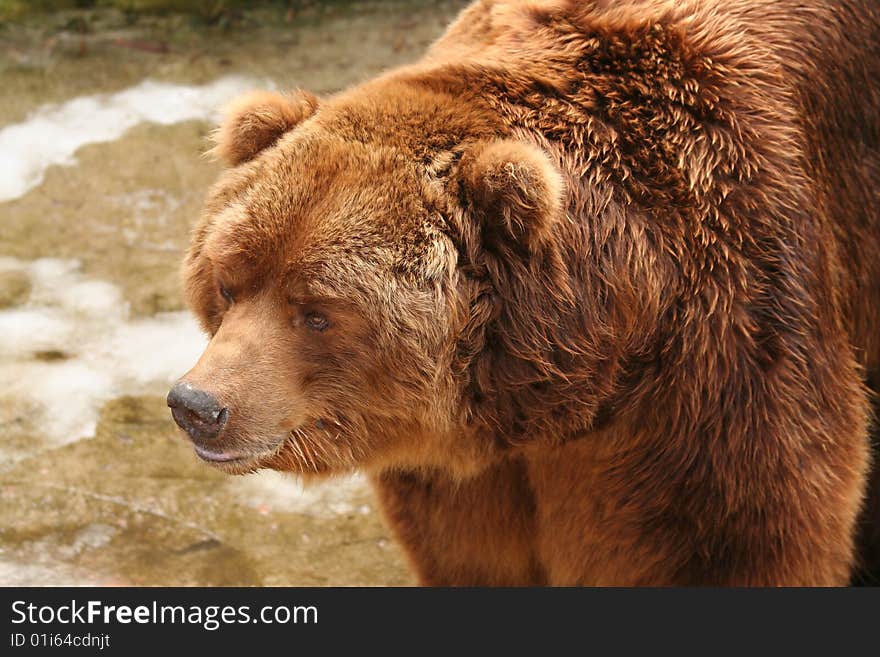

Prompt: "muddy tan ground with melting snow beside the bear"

[0,1,464,585]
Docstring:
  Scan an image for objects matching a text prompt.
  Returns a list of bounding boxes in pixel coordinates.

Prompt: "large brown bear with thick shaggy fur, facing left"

[168,0,880,585]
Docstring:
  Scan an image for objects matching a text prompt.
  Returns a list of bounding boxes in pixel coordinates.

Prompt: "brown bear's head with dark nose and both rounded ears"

[168,84,565,474]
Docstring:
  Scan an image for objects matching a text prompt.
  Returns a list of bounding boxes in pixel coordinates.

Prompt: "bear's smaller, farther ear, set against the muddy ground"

[208,90,318,166]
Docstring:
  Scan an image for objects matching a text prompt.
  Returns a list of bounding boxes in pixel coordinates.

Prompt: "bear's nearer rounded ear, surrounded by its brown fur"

[458,139,565,253]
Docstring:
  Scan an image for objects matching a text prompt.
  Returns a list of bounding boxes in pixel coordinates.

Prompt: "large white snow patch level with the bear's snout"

[0,258,207,456]
